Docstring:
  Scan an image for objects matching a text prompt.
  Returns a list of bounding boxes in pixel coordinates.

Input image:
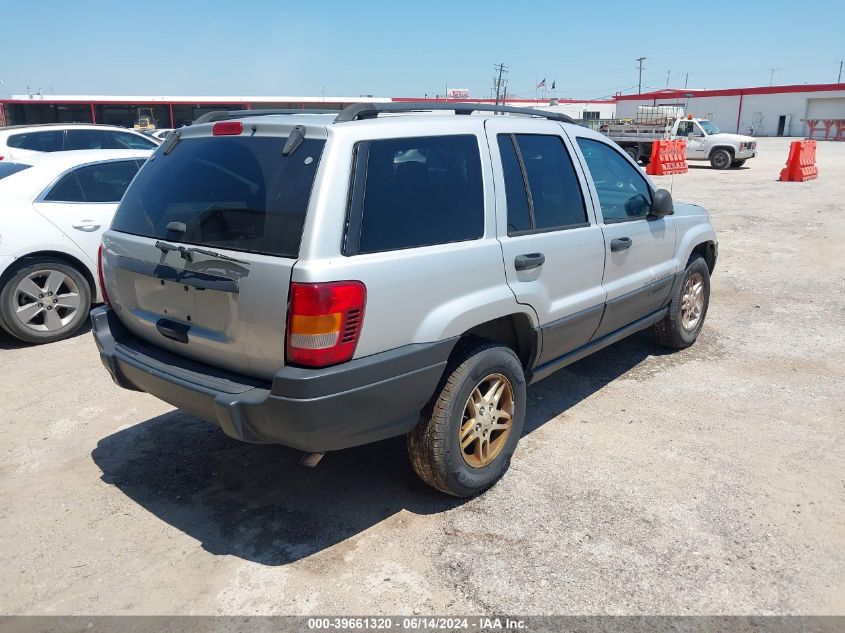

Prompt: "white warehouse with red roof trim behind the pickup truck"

[616,83,845,139]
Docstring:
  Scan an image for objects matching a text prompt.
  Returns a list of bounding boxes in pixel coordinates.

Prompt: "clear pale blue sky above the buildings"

[0,0,845,99]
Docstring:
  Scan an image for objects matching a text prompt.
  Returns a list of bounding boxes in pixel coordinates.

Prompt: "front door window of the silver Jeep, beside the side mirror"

[578,137,651,223]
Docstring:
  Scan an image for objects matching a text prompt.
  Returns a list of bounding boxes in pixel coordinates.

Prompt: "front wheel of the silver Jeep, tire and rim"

[651,255,710,349]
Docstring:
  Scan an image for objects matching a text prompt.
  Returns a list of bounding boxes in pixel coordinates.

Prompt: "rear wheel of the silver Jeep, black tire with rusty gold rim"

[408,342,526,497]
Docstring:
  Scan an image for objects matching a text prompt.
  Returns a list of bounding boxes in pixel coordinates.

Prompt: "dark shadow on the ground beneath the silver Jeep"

[91,336,661,565]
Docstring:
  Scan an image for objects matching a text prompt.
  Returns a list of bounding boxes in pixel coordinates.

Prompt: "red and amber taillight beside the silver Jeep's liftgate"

[287,281,367,367]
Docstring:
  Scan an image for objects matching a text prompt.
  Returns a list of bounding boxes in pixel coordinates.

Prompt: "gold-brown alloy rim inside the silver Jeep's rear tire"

[458,374,514,468]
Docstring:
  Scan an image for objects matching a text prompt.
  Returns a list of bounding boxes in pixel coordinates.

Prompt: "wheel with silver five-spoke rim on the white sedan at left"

[0,257,91,344]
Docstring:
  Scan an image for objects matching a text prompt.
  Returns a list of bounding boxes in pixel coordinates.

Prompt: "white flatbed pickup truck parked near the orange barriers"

[599,106,757,169]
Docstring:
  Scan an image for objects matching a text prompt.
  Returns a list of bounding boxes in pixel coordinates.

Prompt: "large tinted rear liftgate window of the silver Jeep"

[112,136,325,258]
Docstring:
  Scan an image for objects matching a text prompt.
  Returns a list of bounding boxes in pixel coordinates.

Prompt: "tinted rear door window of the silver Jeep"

[497,134,588,235]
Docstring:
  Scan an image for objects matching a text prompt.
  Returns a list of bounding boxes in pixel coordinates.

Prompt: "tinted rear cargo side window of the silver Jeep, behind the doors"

[344,135,484,254]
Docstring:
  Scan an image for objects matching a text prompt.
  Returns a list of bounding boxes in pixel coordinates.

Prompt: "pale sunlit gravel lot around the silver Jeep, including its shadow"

[0,139,845,614]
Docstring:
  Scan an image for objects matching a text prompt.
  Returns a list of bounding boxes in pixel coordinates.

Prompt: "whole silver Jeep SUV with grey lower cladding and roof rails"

[92,104,717,496]
